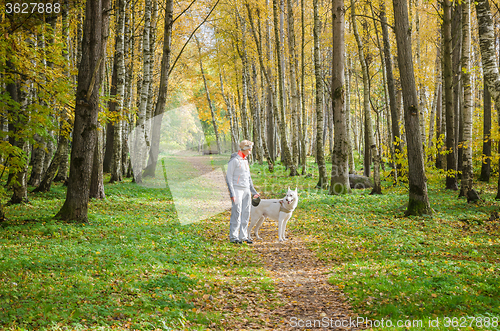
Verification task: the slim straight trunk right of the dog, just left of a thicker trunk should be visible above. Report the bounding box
[313,0,328,189]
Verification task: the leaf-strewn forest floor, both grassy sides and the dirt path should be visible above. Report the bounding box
[0,156,500,331]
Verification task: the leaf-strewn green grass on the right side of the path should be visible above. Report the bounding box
[254,161,500,330]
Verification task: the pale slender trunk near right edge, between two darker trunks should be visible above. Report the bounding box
[460,0,473,197]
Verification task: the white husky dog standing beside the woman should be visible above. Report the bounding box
[248,188,299,241]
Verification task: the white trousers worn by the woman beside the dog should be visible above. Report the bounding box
[229,187,252,241]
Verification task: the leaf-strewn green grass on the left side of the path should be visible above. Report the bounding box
[0,174,278,330]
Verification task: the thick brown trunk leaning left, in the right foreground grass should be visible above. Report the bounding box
[393,0,432,216]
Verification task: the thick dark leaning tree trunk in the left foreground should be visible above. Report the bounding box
[55,0,111,222]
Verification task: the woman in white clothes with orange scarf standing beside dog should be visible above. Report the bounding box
[226,140,259,244]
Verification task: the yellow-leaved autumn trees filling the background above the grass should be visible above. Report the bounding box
[1,0,498,220]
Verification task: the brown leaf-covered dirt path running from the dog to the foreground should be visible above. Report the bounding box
[248,221,359,330]
